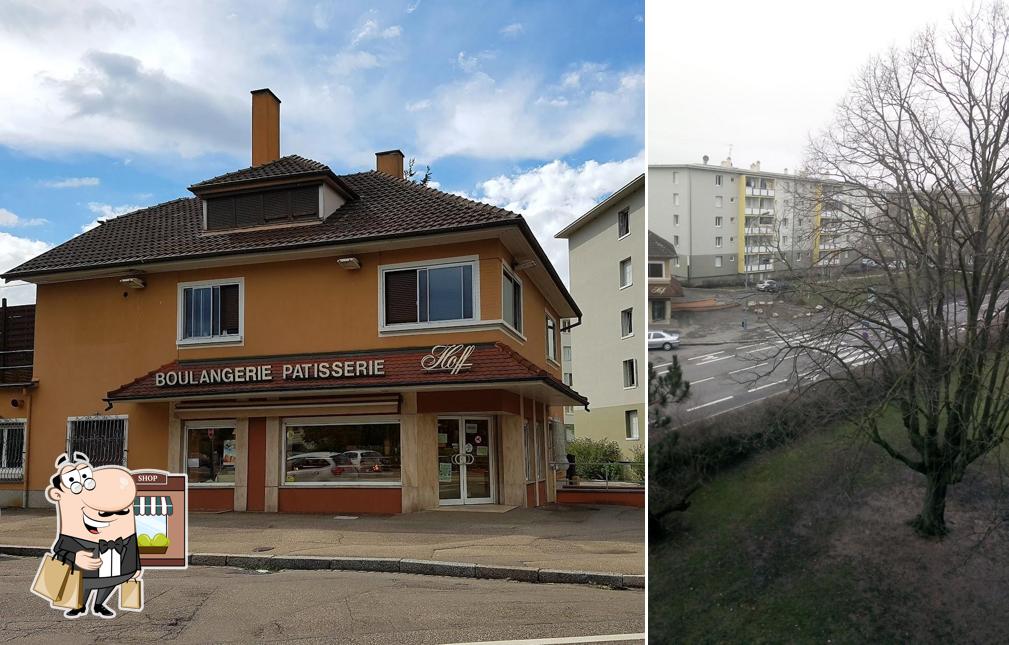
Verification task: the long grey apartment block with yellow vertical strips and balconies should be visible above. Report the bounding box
[648,157,858,286]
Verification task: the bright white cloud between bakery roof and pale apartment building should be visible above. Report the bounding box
[464,150,645,283]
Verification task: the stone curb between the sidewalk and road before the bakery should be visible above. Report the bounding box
[0,544,645,589]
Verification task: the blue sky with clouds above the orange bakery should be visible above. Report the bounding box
[0,0,645,302]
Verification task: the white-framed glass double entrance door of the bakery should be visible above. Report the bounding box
[438,418,495,505]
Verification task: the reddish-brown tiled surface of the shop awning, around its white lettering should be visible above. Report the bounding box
[107,343,588,405]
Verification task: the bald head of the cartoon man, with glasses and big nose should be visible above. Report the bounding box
[45,452,136,542]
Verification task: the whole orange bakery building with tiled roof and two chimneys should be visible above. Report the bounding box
[0,90,588,513]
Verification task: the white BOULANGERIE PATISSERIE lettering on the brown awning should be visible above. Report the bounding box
[154,358,385,388]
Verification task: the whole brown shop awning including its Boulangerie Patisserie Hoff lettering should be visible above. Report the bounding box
[106,343,588,406]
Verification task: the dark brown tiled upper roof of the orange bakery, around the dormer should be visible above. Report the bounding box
[3,166,524,280]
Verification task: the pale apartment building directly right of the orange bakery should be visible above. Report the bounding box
[556,175,648,456]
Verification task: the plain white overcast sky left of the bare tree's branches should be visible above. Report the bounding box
[646,0,970,172]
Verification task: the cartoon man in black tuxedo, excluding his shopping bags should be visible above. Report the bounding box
[45,452,141,618]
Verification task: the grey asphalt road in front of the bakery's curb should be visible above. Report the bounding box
[0,556,645,645]
